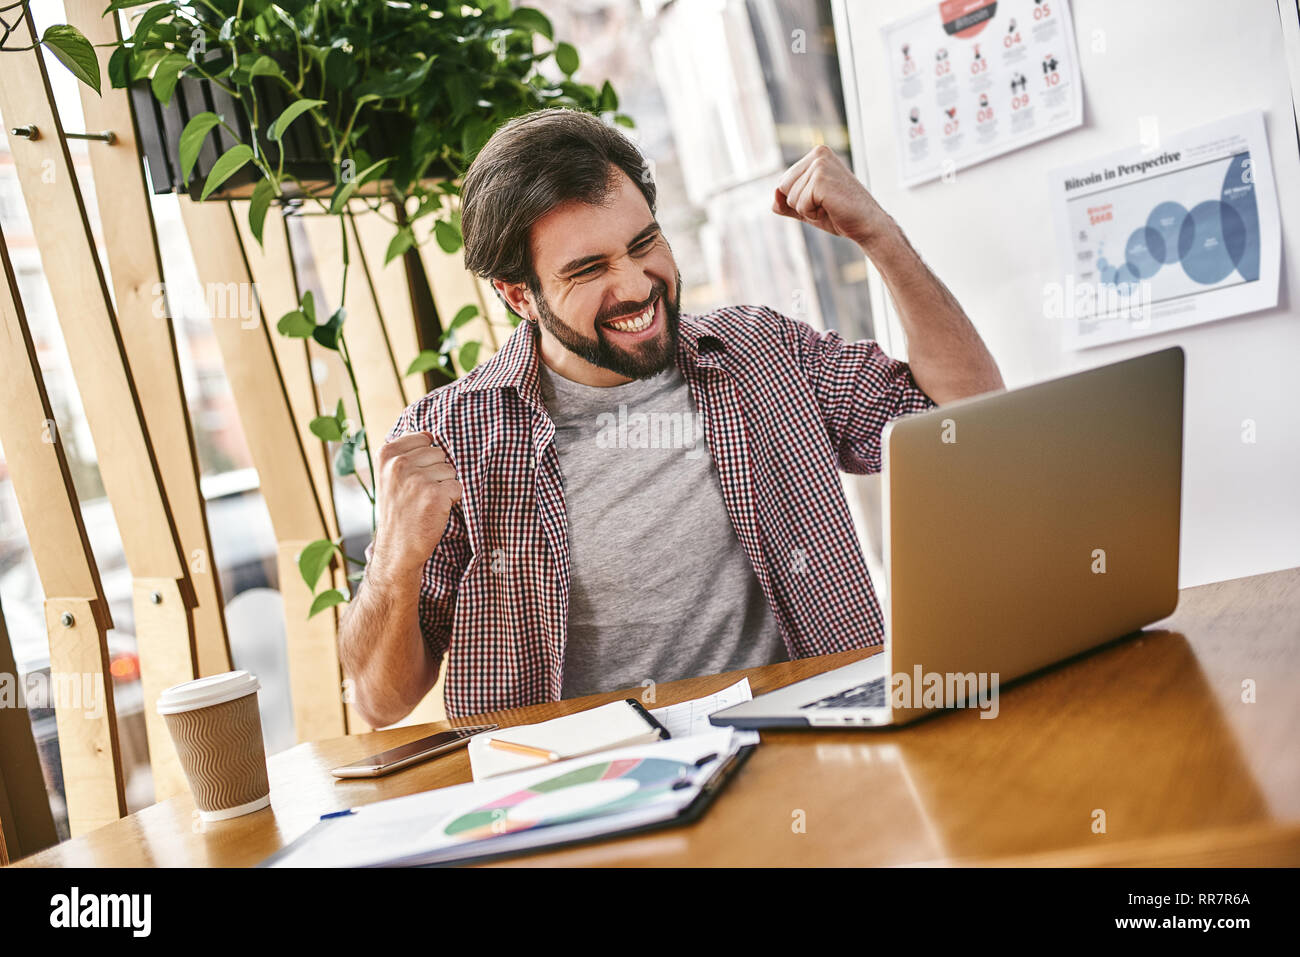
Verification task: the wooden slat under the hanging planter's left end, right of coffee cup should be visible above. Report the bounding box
[179,196,348,741]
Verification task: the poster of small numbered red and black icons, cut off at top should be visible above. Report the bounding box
[881,0,1083,186]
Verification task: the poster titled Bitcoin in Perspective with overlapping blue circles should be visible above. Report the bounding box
[1047,111,1290,348]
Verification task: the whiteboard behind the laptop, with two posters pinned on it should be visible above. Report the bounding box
[833,0,1300,588]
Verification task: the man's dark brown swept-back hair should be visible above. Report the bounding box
[460,107,655,291]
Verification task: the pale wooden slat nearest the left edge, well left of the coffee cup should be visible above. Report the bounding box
[0,226,126,837]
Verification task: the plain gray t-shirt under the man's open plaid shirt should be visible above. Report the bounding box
[538,361,789,698]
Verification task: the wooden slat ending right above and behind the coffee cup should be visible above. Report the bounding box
[64,0,231,681]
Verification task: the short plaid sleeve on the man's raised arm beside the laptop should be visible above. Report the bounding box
[777,313,939,475]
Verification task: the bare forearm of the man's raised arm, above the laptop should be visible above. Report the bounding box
[859,220,1006,404]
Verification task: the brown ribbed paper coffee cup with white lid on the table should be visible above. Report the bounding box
[157,671,270,820]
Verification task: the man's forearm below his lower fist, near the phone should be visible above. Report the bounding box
[338,562,438,727]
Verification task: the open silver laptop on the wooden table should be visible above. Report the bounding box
[710,346,1184,728]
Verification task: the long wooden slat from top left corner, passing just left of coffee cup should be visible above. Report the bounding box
[0,9,198,800]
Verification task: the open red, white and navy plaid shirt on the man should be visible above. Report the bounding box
[367,306,936,718]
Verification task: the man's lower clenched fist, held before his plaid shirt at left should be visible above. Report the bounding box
[373,432,463,575]
